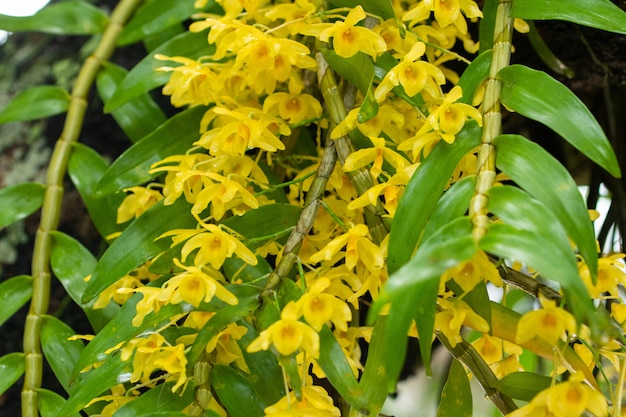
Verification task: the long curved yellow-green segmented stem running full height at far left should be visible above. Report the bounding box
[22,0,141,417]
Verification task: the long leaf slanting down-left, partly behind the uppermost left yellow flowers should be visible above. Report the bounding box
[104,31,215,113]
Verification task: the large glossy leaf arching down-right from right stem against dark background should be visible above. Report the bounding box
[498,65,621,177]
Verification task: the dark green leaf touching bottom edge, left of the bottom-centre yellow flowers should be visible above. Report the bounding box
[210,365,264,417]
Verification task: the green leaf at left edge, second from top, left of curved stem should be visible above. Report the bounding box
[0,84,70,124]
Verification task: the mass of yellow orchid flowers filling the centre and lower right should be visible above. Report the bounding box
[78,0,626,417]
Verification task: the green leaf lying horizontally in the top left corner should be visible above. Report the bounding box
[0,0,109,35]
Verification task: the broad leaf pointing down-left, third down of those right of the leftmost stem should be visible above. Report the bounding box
[82,199,196,302]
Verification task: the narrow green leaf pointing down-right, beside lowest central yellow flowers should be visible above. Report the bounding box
[317,326,360,408]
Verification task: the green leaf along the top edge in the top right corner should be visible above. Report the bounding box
[511,0,626,34]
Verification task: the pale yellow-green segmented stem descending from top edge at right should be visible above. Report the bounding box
[470,0,513,241]
